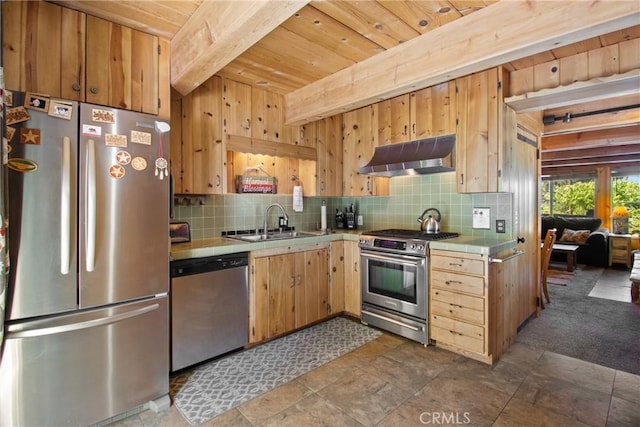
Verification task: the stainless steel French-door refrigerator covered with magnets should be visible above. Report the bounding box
[0,92,169,426]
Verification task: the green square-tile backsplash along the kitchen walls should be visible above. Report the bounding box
[173,172,513,239]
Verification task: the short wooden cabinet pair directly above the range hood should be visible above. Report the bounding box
[378,82,456,145]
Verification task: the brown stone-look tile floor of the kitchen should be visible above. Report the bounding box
[105,326,640,427]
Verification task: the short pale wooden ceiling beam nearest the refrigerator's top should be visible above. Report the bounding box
[171,0,309,95]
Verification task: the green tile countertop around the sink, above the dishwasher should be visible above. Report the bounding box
[170,230,366,260]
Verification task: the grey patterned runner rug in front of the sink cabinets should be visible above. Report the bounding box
[174,317,382,424]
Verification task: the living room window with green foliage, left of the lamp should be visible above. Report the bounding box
[540,178,596,216]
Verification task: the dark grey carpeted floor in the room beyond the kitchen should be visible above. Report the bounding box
[517,266,640,375]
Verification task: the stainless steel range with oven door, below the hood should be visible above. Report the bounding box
[358,229,458,345]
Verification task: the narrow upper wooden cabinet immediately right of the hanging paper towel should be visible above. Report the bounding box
[316,115,343,196]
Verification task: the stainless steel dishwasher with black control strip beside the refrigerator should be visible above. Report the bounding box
[170,252,249,371]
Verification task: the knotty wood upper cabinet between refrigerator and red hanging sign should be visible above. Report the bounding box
[171,76,227,194]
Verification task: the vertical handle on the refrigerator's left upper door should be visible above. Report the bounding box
[60,136,71,275]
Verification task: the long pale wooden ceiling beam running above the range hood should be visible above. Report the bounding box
[285,0,640,124]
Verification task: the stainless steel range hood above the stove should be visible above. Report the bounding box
[359,134,456,177]
